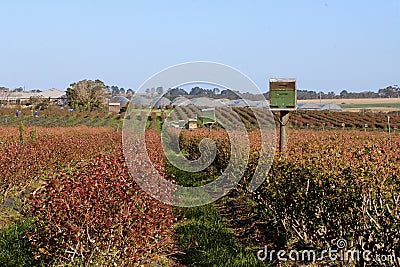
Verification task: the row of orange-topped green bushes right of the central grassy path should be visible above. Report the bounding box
[180,130,400,266]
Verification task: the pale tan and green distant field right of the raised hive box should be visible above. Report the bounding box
[298,98,400,112]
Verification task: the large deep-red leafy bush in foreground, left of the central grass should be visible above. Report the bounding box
[29,149,175,266]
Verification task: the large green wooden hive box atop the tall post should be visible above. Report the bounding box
[269,78,297,110]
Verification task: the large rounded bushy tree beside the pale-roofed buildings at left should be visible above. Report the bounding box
[67,80,109,110]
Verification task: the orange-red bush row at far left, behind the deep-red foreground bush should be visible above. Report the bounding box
[0,126,121,203]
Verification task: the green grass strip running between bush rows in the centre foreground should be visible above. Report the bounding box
[167,165,266,266]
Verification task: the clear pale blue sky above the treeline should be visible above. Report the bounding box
[0,0,400,93]
